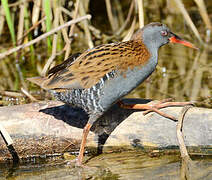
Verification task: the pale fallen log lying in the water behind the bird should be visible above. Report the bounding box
[0,99,212,160]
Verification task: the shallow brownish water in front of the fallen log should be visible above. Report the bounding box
[0,151,212,180]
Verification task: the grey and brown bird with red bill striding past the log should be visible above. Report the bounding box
[28,22,197,165]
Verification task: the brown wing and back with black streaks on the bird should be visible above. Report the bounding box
[41,40,150,89]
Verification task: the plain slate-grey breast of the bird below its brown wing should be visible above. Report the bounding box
[99,57,157,110]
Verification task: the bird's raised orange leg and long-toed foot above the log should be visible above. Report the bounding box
[119,99,194,121]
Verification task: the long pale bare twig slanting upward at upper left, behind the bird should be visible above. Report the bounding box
[0,15,91,59]
